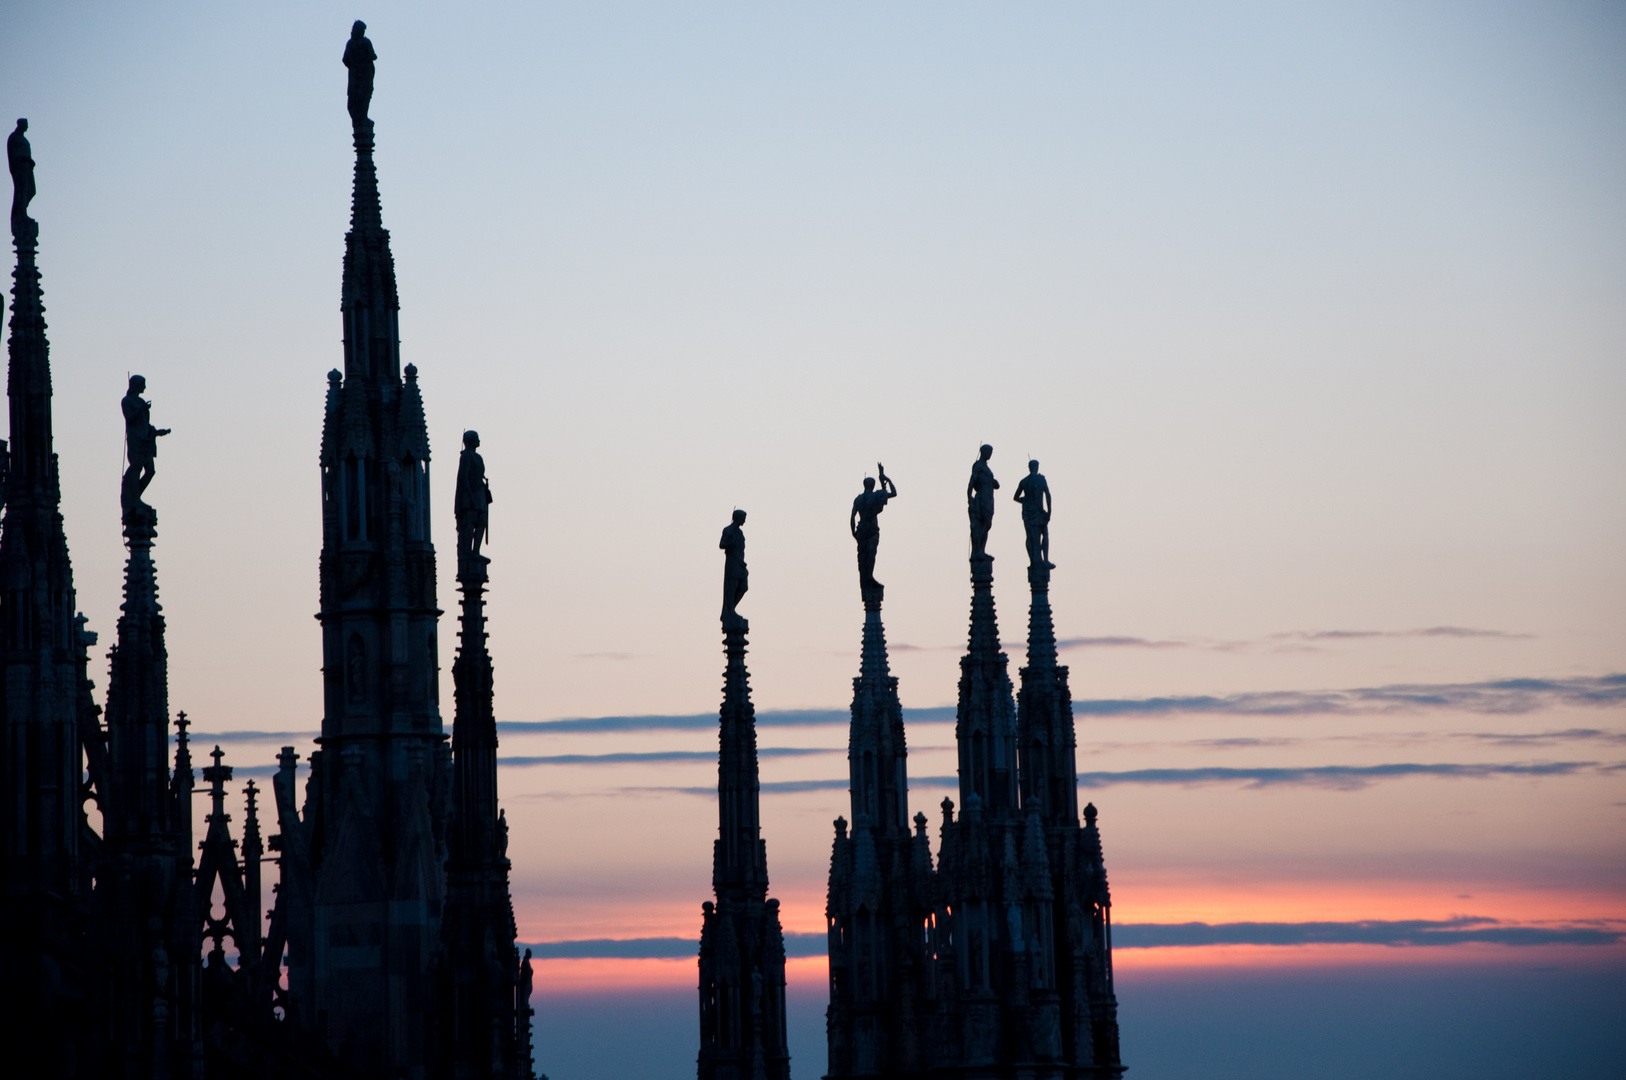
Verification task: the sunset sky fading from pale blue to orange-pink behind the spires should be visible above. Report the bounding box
[0,0,1626,1080]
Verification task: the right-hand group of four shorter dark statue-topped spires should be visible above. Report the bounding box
[699,446,1125,1080]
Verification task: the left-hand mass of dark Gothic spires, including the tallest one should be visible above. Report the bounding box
[0,23,535,1080]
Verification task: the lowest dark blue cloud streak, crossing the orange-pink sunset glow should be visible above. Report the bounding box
[522,916,1626,960]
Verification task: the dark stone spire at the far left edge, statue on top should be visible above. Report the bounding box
[0,120,106,1046]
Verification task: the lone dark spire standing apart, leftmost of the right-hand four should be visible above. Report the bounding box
[699,511,790,1080]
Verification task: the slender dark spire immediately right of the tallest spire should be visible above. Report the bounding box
[441,449,533,1080]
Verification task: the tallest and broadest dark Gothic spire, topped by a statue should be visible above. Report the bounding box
[273,24,450,1075]
